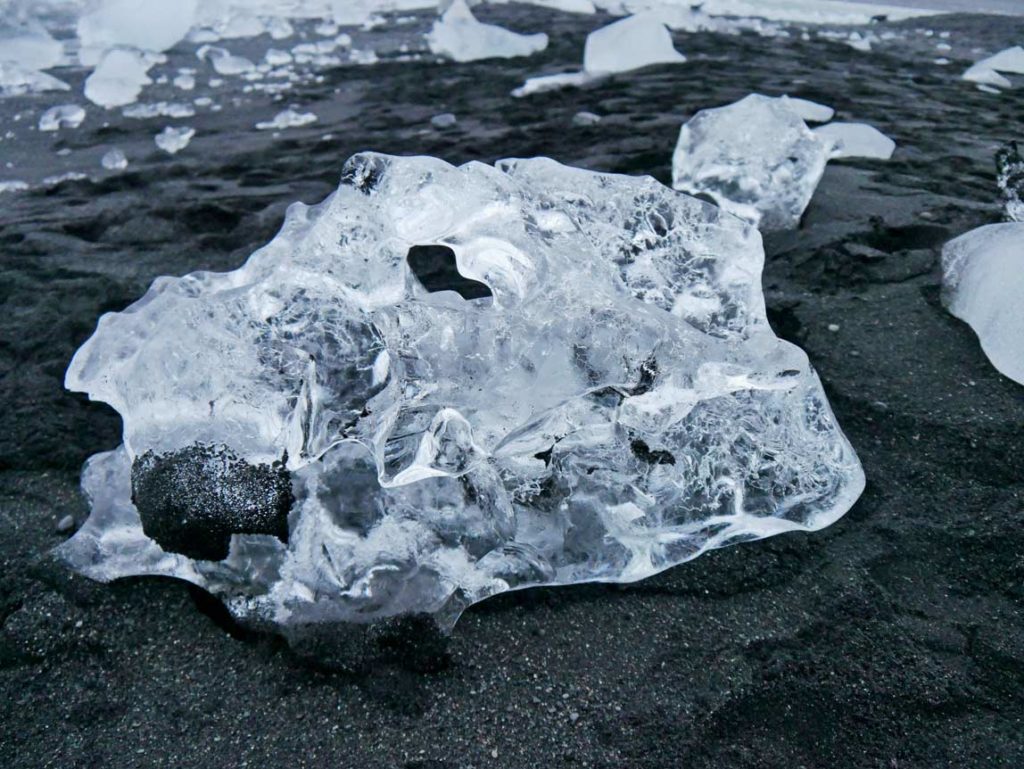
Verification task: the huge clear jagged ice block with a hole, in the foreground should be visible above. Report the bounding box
[59,151,864,628]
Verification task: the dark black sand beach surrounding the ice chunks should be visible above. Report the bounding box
[0,8,1024,769]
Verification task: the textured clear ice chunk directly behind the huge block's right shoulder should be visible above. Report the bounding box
[672,93,833,230]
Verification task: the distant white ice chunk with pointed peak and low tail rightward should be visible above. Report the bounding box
[427,0,548,61]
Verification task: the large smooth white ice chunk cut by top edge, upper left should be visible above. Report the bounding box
[78,0,199,65]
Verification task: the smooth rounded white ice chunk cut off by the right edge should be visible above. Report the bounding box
[942,221,1024,384]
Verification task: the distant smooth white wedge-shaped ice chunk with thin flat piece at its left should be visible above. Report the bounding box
[583,13,686,75]
